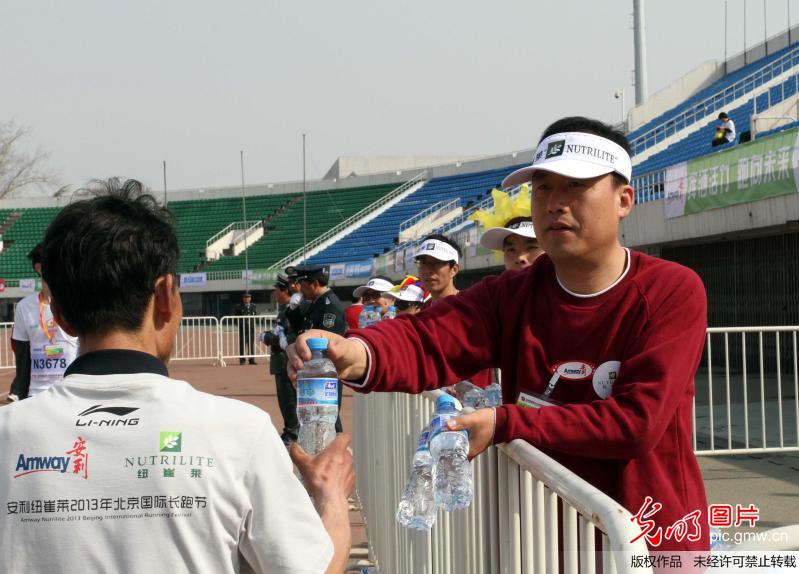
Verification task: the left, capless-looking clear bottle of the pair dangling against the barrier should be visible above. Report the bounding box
[396,427,436,530]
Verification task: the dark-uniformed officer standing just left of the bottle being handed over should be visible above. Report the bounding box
[259,273,300,446]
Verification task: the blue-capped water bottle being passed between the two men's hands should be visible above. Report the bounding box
[297,338,339,454]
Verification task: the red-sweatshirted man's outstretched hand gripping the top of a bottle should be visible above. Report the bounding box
[286,329,368,381]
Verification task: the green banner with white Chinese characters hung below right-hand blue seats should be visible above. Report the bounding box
[665,128,799,218]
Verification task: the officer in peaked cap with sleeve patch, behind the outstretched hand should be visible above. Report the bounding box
[296,265,347,432]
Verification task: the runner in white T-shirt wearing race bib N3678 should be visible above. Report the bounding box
[11,244,78,399]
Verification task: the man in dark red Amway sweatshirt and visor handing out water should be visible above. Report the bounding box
[290,117,709,551]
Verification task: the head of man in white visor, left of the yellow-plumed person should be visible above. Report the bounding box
[413,233,463,304]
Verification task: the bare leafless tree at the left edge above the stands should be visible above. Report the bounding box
[0,121,58,199]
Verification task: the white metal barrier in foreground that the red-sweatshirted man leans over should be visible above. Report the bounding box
[353,393,651,574]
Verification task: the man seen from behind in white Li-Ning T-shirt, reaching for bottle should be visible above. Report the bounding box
[0,180,355,573]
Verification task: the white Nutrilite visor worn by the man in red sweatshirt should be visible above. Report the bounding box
[502,132,633,187]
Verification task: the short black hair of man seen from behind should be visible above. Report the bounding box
[42,178,180,335]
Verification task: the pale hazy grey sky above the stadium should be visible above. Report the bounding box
[0,0,799,195]
